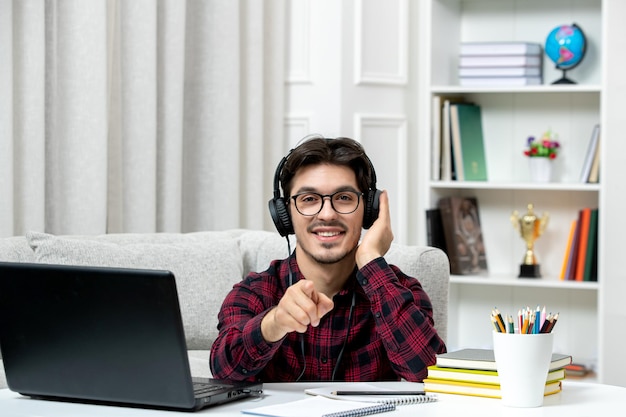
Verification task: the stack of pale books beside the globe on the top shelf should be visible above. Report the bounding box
[459,42,543,86]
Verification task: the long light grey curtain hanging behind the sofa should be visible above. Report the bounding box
[0,0,285,236]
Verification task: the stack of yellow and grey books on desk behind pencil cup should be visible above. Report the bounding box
[424,349,572,398]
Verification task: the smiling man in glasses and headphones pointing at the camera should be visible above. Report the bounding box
[210,138,446,382]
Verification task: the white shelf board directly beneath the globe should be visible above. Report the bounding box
[430,84,602,94]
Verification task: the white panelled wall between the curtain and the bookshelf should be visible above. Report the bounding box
[285,0,418,243]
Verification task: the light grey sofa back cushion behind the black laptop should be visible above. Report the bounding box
[26,232,243,350]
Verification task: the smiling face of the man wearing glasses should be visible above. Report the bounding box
[289,164,364,264]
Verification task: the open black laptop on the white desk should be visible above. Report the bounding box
[0,262,262,410]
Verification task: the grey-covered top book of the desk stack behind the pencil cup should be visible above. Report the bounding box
[435,348,572,371]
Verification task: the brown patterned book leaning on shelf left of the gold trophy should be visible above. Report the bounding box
[437,196,487,275]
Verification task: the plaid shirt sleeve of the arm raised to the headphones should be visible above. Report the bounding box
[357,257,446,381]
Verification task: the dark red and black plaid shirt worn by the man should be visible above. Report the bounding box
[210,257,446,382]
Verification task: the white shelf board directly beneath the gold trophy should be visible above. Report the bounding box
[450,275,598,291]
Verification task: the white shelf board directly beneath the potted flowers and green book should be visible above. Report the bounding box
[430,181,600,192]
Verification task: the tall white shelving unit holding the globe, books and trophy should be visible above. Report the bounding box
[418,0,626,384]
